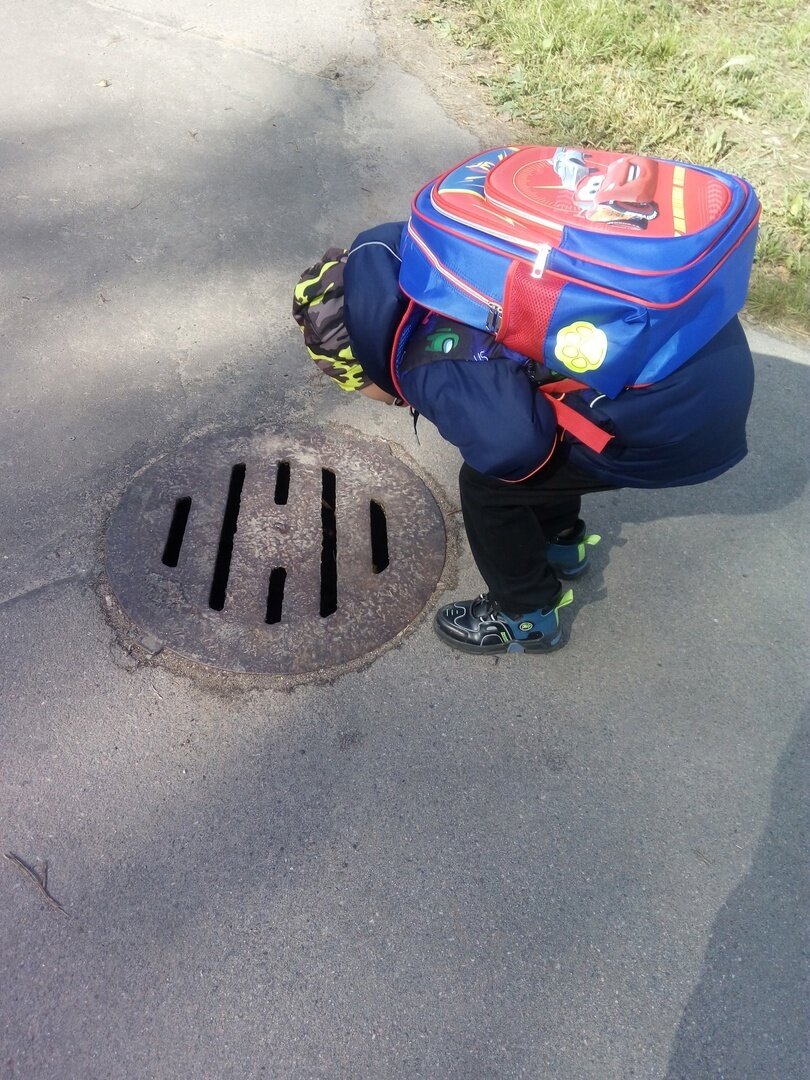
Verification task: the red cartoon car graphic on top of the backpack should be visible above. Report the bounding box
[551,147,659,229]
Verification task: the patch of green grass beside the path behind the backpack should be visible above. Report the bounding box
[415,0,810,333]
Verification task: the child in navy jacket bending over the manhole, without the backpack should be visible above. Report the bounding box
[293,222,754,653]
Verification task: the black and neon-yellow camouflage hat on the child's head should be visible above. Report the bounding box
[293,247,369,390]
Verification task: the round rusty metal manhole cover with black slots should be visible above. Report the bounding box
[107,429,445,675]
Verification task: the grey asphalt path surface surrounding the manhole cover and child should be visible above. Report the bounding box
[0,0,810,1080]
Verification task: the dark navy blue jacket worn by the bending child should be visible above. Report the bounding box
[343,222,754,487]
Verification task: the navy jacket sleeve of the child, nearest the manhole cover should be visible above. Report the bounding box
[401,360,556,482]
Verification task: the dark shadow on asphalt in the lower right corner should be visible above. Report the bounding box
[666,718,810,1080]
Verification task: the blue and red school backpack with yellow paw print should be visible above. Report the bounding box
[392,146,761,448]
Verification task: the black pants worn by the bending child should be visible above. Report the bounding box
[459,458,617,615]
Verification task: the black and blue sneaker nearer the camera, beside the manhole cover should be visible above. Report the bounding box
[433,589,573,652]
